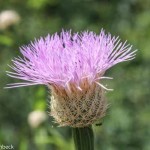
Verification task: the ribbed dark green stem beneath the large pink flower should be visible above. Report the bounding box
[72,126,94,150]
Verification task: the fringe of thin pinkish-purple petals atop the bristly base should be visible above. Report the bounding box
[7,30,136,90]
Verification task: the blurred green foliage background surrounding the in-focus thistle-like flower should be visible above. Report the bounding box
[0,0,150,150]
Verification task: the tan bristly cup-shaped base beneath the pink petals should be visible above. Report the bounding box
[50,84,107,128]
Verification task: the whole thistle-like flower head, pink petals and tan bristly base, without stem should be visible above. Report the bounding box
[7,30,136,127]
